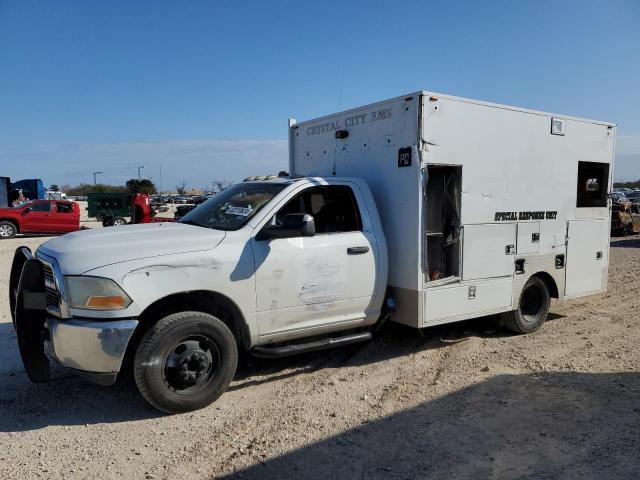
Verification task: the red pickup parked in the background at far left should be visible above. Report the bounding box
[0,200,80,239]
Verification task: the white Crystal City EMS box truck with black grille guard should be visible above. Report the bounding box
[10,91,615,412]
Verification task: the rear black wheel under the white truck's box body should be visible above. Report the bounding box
[502,277,551,333]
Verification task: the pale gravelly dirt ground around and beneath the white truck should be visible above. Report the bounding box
[0,228,640,479]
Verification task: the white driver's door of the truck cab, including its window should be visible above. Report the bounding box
[252,185,378,337]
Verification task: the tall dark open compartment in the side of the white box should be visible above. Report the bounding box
[426,165,462,282]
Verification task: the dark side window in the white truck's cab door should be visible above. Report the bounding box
[275,185,362,233]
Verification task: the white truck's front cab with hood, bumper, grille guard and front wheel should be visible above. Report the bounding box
[11,177,387,412]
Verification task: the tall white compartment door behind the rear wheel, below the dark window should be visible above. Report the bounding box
[565,220,607,297]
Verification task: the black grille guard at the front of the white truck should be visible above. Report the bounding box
[9,247,49,383]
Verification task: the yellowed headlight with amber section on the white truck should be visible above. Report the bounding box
[65,276,131,310]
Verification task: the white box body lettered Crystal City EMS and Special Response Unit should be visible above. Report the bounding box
[289,91,615,327]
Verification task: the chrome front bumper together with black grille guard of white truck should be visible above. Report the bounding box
[9,247,138,385]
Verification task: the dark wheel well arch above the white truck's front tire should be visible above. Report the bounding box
[132,290,251,347]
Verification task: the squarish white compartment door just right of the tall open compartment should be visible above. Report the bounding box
[462,223,516,280]
